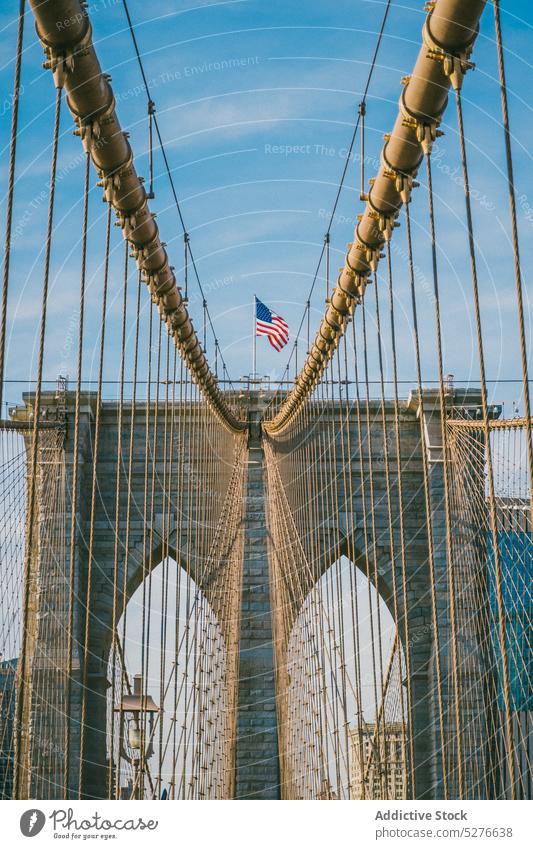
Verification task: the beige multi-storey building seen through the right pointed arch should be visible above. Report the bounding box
[350,722,407,799]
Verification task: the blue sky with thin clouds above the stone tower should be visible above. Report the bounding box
[0,0,533,412]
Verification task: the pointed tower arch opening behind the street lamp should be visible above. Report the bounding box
[107,556,234,799]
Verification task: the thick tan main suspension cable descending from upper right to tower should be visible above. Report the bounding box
[264,0,486,434]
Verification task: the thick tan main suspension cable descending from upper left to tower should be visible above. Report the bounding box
[31,0,245,433]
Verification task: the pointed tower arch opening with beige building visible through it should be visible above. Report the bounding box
[278,556,408,799]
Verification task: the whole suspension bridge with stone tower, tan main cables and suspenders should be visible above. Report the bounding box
[0,0,533,800]
